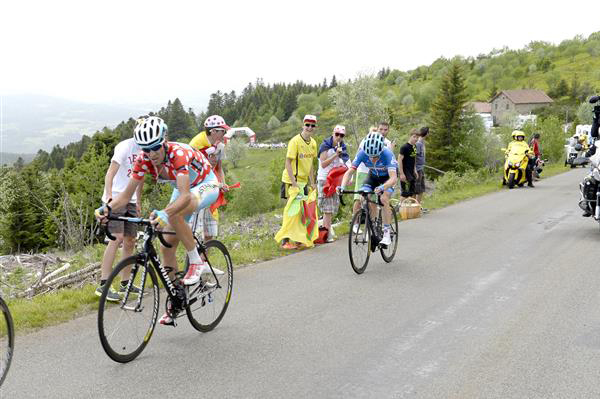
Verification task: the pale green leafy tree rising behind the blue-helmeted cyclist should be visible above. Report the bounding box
[330,75,385,147]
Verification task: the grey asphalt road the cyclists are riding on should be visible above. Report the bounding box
[0,169,600,399]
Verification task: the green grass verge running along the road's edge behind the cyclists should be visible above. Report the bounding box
[8,164,570,333]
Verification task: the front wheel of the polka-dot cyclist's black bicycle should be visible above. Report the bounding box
[98,255,159,363]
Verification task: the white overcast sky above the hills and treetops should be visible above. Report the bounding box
[0,0,600,109]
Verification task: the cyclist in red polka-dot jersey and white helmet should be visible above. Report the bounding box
[96,116,223,325]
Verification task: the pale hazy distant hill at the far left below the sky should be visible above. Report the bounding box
[0,95,158,153]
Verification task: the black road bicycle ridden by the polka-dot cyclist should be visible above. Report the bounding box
[98,215,233,363]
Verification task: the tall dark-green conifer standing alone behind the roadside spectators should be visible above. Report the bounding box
[428,63,467,171]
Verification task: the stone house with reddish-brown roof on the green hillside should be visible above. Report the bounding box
[491,89,554,126]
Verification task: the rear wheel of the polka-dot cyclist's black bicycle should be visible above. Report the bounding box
[185,240,233,332]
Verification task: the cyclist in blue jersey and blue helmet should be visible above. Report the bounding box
[338,132,398,245]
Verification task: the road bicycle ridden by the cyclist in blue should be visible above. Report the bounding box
[342,190,398,274]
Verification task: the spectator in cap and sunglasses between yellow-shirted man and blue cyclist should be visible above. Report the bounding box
[317,125,350,242]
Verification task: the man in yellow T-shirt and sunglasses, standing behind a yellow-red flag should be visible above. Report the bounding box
[280,115,317,249]
